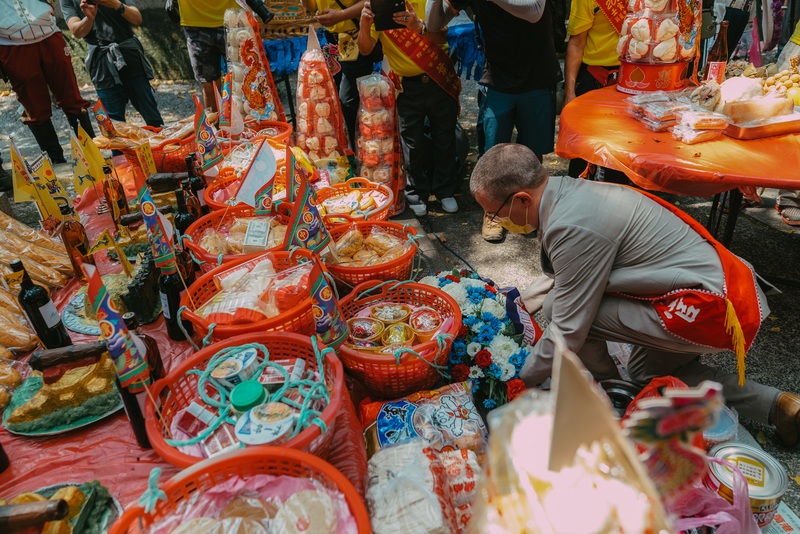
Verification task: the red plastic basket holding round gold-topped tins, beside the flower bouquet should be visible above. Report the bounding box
[339,280,461,398]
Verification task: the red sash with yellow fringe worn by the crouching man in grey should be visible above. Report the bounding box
[616,190,764,385]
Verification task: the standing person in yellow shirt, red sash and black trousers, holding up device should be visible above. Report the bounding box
[358,0,461,217]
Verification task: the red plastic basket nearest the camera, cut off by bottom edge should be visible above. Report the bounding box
[108,447,372,534]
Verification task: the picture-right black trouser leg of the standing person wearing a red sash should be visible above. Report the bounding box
[423,80,458,205]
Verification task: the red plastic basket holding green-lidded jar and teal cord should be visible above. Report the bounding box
[145,332,344,468]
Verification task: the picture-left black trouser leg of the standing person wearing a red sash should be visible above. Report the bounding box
[397,82,431,214]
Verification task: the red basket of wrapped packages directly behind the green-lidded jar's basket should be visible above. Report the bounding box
[181,249,318,339]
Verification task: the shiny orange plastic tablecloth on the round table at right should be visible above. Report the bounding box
[556,87,800,197]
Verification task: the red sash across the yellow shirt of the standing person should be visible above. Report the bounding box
[383,28,461,102]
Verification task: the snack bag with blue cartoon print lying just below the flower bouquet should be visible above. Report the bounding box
[361,381,487,457]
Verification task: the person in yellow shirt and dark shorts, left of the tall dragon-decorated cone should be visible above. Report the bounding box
[178,0,239,111]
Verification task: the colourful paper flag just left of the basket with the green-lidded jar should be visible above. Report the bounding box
[79,260,150,393]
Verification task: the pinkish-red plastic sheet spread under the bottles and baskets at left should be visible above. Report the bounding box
[0,157,367,508]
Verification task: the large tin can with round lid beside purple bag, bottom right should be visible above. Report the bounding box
[703,442,789,530]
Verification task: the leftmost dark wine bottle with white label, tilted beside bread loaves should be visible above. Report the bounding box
[9,260,72,349]
